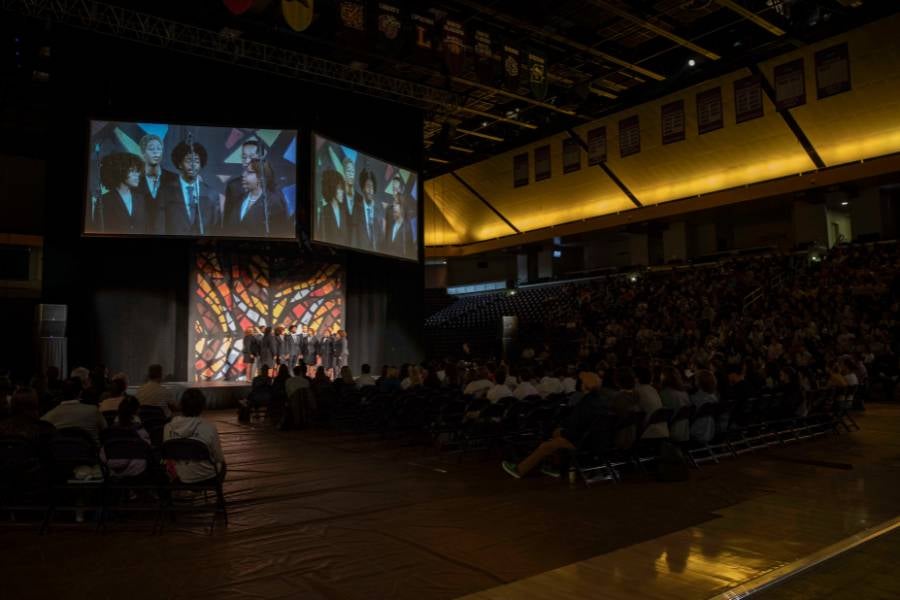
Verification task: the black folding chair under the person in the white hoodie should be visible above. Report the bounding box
[160,438,228,533]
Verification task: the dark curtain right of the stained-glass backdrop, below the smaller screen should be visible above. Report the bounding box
[346,253,424,374]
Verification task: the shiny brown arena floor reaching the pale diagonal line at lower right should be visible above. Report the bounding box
[0,406,900,600]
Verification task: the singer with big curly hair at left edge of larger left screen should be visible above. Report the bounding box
[93,152,147,234]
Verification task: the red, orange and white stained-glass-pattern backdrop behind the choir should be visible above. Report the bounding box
[188,249,344,381]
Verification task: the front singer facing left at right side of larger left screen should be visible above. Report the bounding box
[224,158,293,237]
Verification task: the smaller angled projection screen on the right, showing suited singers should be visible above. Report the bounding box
[312,134,419,261]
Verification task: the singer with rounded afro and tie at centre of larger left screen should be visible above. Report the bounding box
[160,142,221,236]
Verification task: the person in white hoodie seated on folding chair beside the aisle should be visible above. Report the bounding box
[163,389,226,483]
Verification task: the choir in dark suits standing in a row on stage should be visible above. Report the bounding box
[243,324,350,381]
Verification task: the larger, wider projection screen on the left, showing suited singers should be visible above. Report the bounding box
[84,121,297,239]
